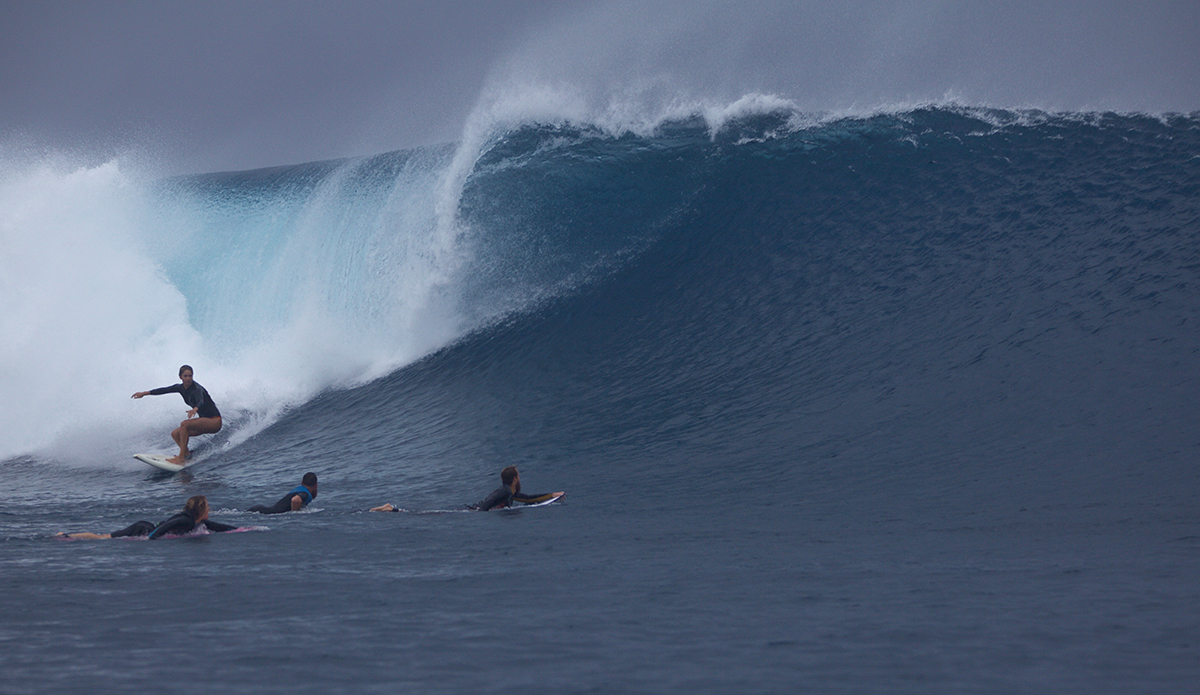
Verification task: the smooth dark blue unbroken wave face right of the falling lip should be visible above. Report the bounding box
[225,109,1200,513]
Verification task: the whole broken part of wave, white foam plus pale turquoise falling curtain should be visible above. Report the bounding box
[0,144,469,466]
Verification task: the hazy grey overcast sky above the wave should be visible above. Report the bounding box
[0,0,1200,172]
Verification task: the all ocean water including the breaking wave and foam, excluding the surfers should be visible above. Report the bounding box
[0,103,1200,695]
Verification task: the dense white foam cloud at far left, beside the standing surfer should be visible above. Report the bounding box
[0,161,204,459]
